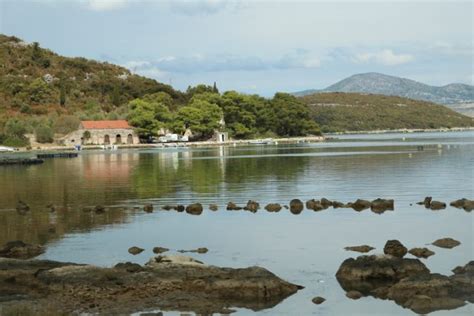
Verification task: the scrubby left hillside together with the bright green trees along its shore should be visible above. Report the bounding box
[0,35,320,146]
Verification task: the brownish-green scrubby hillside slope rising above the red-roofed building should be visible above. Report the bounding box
[0,34,184,119]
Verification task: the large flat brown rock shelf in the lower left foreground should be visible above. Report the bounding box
[0,255,302,315]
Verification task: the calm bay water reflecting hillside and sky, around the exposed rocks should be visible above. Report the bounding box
[0,132,474,315]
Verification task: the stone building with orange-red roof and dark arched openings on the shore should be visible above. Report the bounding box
[60,120,140,145]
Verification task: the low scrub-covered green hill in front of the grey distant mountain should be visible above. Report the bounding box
[300,92,474,132]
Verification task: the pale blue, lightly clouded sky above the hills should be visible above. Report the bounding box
[0,0,474,96]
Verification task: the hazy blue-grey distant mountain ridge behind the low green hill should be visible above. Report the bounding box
[294,72,474,105]
